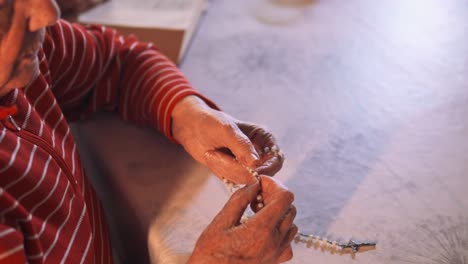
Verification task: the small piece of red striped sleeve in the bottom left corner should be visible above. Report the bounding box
[0,224,27,264]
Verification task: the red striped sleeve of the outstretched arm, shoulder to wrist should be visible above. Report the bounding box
[43,20,219,140]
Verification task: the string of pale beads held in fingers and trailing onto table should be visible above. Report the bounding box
[223,146,377,256]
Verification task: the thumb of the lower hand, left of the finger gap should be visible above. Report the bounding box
[213,182,260,229]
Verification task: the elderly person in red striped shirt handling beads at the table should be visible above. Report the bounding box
[0,0,297,263]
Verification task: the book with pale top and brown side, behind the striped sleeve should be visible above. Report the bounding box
[78,0,208,64]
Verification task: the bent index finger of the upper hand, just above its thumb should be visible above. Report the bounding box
[223,124,260,168]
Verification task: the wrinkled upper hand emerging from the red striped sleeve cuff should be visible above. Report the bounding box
[172,96,283,184]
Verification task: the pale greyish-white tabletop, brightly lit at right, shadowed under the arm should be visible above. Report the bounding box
[74,0,468,264]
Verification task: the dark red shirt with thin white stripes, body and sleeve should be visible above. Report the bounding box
[0,21,215,263]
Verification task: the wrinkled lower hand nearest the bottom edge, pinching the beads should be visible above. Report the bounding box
[188,176,297,264]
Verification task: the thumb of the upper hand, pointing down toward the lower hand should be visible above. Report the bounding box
[205,150,256,184]
